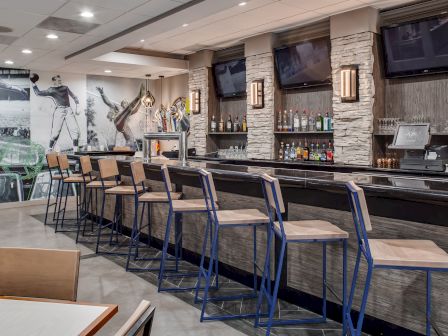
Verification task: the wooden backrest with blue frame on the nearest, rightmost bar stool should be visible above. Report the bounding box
[345,181,372,255]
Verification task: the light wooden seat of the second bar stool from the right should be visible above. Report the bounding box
[274,220,348,240]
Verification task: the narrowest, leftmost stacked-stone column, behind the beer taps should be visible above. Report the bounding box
[188,67,209,155]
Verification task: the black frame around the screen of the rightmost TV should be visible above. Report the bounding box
[380,14,448,79]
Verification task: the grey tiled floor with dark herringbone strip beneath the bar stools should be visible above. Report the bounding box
[0,201,342,336]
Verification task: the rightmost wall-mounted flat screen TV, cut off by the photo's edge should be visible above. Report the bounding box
[382,15,448,78]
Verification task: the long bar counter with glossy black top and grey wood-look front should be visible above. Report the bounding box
[71,155,448,335]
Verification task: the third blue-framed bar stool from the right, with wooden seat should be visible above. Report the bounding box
[195,169,269,322]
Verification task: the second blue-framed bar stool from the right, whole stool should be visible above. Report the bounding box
[255,174,349,336]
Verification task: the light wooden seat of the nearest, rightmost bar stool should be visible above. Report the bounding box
[369,239,448,268]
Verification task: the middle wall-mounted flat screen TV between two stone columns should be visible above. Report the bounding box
[275,37,331,89]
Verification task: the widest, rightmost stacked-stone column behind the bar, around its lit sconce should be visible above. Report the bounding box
[331,32,376,165]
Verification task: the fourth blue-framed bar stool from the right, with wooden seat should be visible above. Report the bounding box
[158,165,218,292]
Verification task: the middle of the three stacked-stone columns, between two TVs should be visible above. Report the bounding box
[246,53,275,159]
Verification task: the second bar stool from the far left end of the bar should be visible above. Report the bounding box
[55,154,93,232]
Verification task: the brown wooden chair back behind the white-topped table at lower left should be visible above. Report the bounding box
[0,247,80,301]
